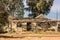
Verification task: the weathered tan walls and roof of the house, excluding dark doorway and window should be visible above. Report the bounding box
[8,15,60,31]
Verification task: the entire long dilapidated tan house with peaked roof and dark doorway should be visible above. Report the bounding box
[3,14,60,32]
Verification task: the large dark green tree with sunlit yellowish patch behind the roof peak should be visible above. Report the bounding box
[27,0,54,18]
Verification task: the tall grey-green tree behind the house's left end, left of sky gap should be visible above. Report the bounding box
[4,0,24,18]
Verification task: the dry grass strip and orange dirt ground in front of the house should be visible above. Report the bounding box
[0,31,60,40]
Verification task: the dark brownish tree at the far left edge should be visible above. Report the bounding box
[0,0,8,26]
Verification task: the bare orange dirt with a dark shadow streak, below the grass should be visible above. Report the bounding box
[0,34,60,40]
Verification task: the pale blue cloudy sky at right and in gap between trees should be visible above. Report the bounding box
[24,0,60,20]
